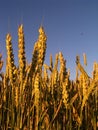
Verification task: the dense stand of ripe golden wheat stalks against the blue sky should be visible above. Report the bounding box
[0,25,98,130]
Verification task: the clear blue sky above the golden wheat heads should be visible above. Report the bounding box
[0,0,98,79]
